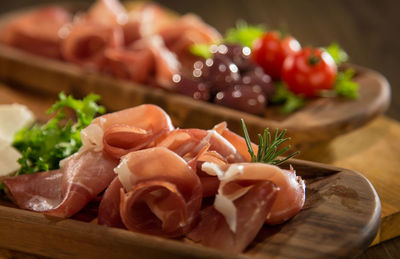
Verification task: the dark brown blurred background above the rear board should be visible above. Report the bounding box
[0,0,400,120]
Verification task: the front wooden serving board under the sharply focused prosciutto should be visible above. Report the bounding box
[0,160,381,258]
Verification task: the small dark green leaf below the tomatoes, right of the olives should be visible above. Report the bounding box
[271,81,305,114]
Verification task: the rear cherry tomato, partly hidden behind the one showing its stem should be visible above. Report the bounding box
[252,31,301,80]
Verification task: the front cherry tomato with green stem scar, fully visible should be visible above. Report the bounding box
[282,48,337,97]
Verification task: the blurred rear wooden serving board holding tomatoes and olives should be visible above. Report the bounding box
[0,5,390,149]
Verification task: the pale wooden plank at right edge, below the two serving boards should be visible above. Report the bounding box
[301,117,400,243]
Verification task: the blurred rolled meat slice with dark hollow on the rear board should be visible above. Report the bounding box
[61,21,123,69]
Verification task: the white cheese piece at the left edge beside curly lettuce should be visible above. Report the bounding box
[0,103,35,143]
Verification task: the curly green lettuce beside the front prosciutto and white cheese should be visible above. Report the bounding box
[13,93,105,175]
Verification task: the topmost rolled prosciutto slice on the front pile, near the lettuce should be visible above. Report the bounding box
[81,104,174,158]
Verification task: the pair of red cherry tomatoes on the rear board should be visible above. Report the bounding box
[252,31,337,97]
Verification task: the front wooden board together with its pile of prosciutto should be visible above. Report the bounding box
[0,105,380,258]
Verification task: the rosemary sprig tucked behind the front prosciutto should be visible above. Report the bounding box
[240,119,300,165]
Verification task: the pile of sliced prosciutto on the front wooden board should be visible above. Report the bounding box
[3,105,305,252]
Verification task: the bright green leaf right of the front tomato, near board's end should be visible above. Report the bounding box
[335,69,359,99]
